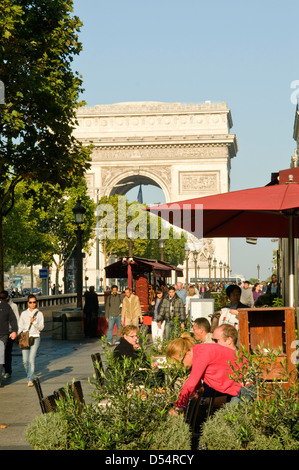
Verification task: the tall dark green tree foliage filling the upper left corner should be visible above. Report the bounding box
[0,0,90,283]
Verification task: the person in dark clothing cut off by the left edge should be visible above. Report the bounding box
[0,299,18,387]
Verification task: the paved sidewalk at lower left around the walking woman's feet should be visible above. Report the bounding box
[0,337,102,450]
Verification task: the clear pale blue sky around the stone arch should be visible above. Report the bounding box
[74,0,299,279]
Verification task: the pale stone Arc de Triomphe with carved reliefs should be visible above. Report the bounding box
[74,101,238,285]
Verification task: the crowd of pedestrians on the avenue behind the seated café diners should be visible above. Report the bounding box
[105,274,281,345]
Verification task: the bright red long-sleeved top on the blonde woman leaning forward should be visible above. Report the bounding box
[175,343,242,408]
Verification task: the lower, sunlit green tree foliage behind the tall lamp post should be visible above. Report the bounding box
[3,178,95,284]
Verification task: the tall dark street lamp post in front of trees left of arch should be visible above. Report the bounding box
[73,198,86,308]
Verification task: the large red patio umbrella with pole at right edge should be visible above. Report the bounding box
[147,168,299,306]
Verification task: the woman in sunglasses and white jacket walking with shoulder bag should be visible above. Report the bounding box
[18,294,44,387]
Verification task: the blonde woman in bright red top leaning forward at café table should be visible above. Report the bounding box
[166,333,246,411]
